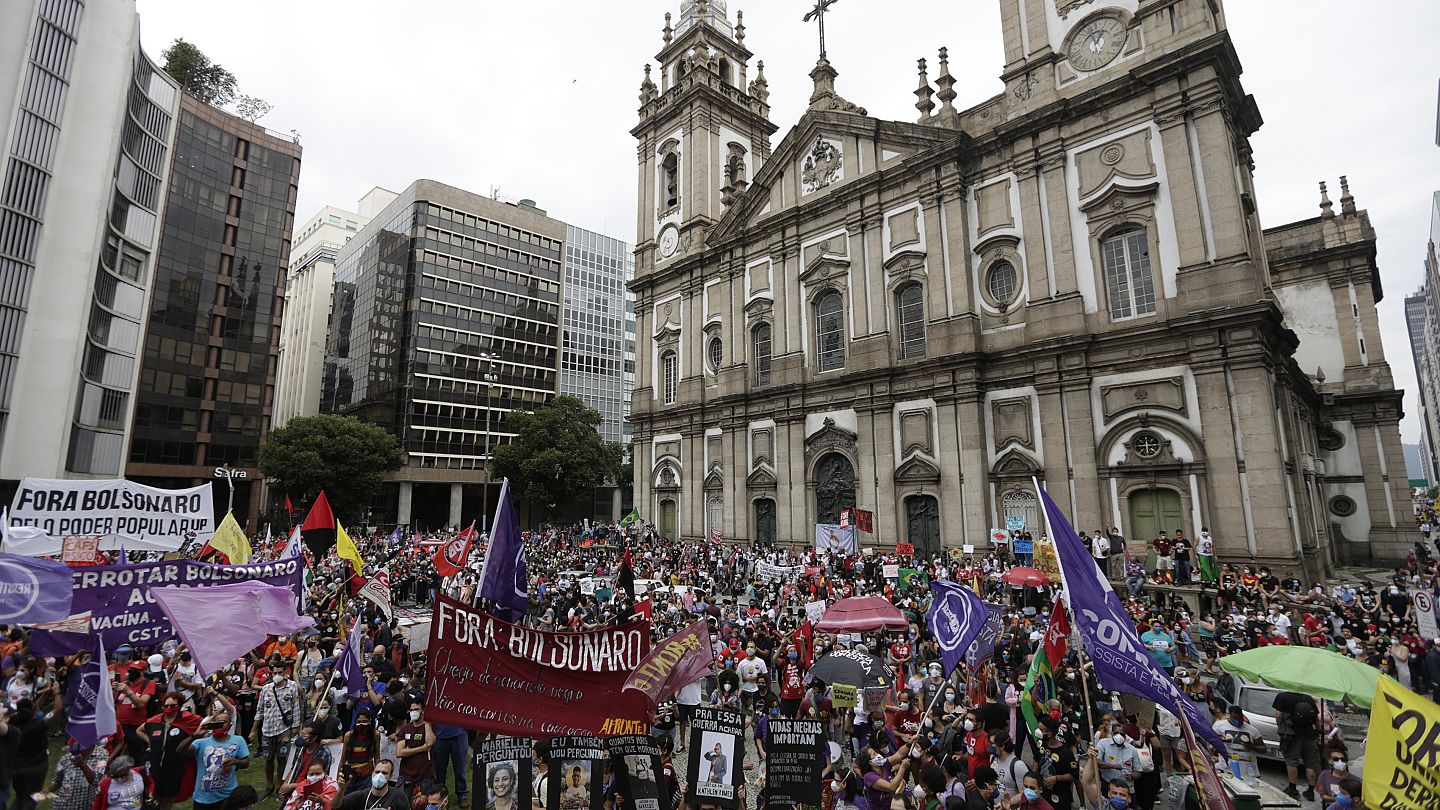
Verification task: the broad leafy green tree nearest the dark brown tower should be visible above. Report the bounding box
[261,415,405,523]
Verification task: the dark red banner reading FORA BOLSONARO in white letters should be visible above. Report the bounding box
[425,597,649,736]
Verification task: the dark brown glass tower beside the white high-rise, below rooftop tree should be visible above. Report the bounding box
[125,95,301,526]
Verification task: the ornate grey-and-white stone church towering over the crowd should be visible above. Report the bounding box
[631,0,1414,577]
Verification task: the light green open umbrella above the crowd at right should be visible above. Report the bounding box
[1220,644,1380,709]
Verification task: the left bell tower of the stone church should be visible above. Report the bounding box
[631,0,775,275]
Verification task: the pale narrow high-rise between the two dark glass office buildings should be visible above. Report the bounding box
[271,187,396,428]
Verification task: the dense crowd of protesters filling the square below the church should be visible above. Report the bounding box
[0,469,1440,810]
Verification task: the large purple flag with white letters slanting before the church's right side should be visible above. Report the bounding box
[1035,483,1225,751]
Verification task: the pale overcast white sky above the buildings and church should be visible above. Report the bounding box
[140,0,1440,442]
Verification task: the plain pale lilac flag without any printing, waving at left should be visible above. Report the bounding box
[150,579,315,676]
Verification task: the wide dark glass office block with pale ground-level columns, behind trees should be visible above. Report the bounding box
[321,180,566,528]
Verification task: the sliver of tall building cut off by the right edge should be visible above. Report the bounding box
[1405,192,1440,484]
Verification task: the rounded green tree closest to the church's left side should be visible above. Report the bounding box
[492,396,622,517]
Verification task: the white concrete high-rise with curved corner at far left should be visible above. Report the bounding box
[0,0,180,500]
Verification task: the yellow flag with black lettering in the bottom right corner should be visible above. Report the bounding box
[1364,675,1440,810]
